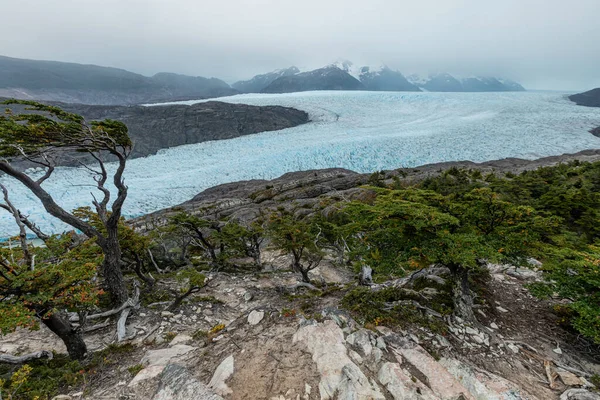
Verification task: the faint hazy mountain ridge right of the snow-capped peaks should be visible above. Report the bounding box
[408,72,525,92]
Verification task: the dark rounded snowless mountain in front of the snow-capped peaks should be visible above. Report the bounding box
[262,66,365,93]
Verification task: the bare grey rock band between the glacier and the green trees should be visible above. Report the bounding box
[135,149,600,230]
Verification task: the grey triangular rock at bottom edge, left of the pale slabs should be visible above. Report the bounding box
[152,364,223,400]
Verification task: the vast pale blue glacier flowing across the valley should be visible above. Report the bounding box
[0,92,600,237]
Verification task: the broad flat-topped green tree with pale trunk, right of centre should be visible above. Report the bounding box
[343,188,556,322]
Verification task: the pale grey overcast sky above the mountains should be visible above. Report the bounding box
[0,0,600,90]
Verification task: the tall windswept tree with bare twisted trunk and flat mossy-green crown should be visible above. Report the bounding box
[0,100,132,303]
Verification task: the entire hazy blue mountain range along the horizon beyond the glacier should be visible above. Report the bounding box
[0,56,525,105]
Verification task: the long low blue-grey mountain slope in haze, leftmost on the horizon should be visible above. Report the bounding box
[0,56,238,104]
